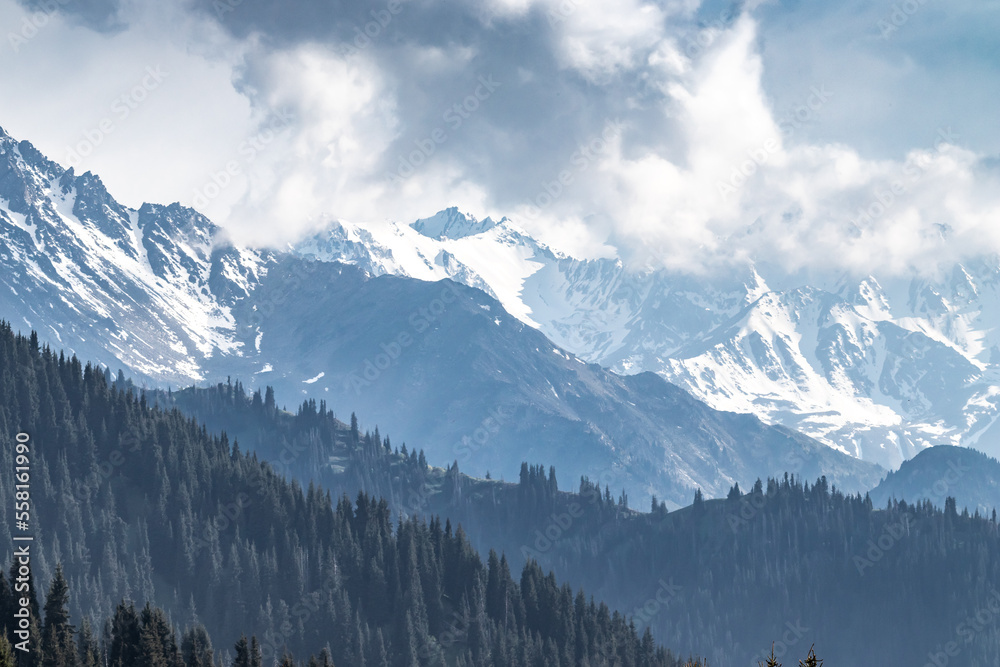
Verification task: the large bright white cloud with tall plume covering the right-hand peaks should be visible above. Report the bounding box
[504,16,1000,280]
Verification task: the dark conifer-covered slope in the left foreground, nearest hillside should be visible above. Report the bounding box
[0,324,700,667]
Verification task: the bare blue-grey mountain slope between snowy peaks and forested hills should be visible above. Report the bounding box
[229,256,884,507]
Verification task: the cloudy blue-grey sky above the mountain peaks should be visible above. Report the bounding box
[0,0,1000,274]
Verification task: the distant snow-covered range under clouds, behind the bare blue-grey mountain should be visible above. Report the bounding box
[296,209,1000,467]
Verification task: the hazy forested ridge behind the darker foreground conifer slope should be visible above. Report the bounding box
[146,380,1000,667]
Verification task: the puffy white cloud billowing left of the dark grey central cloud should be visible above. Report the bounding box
[214,44,397,242]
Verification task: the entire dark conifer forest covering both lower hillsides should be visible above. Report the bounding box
[9,326,1000,667]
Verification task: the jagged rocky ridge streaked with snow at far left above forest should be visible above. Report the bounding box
[0,127,267,382]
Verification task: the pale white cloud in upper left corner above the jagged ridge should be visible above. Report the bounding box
[0,0,254,206]
